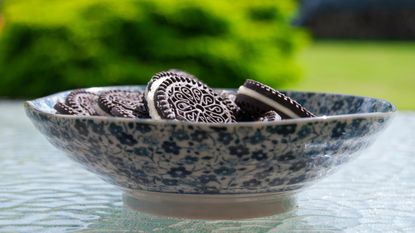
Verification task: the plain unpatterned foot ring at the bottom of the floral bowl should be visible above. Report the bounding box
[123,192,296,220]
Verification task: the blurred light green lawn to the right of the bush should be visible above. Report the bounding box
[286,41,415,110]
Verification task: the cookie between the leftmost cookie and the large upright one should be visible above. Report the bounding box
[96,90,149,118]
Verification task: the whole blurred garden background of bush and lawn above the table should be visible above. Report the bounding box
[0,0,415,110]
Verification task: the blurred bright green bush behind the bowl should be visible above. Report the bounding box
[0,0,306,97]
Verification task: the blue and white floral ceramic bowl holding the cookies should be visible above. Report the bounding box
[25,86,395,219]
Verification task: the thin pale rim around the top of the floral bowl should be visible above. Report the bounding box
[24,85,396,127]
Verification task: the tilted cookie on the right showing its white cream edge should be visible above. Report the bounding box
[235,79,315,119]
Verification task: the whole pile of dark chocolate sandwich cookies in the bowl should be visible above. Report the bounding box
[54,70,315,123]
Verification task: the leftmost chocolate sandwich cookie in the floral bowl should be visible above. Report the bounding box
[54,90,98,116]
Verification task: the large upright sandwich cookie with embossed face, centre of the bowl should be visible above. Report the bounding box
[146,71,235,123]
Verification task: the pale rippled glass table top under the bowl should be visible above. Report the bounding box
[0,101,415,232]
